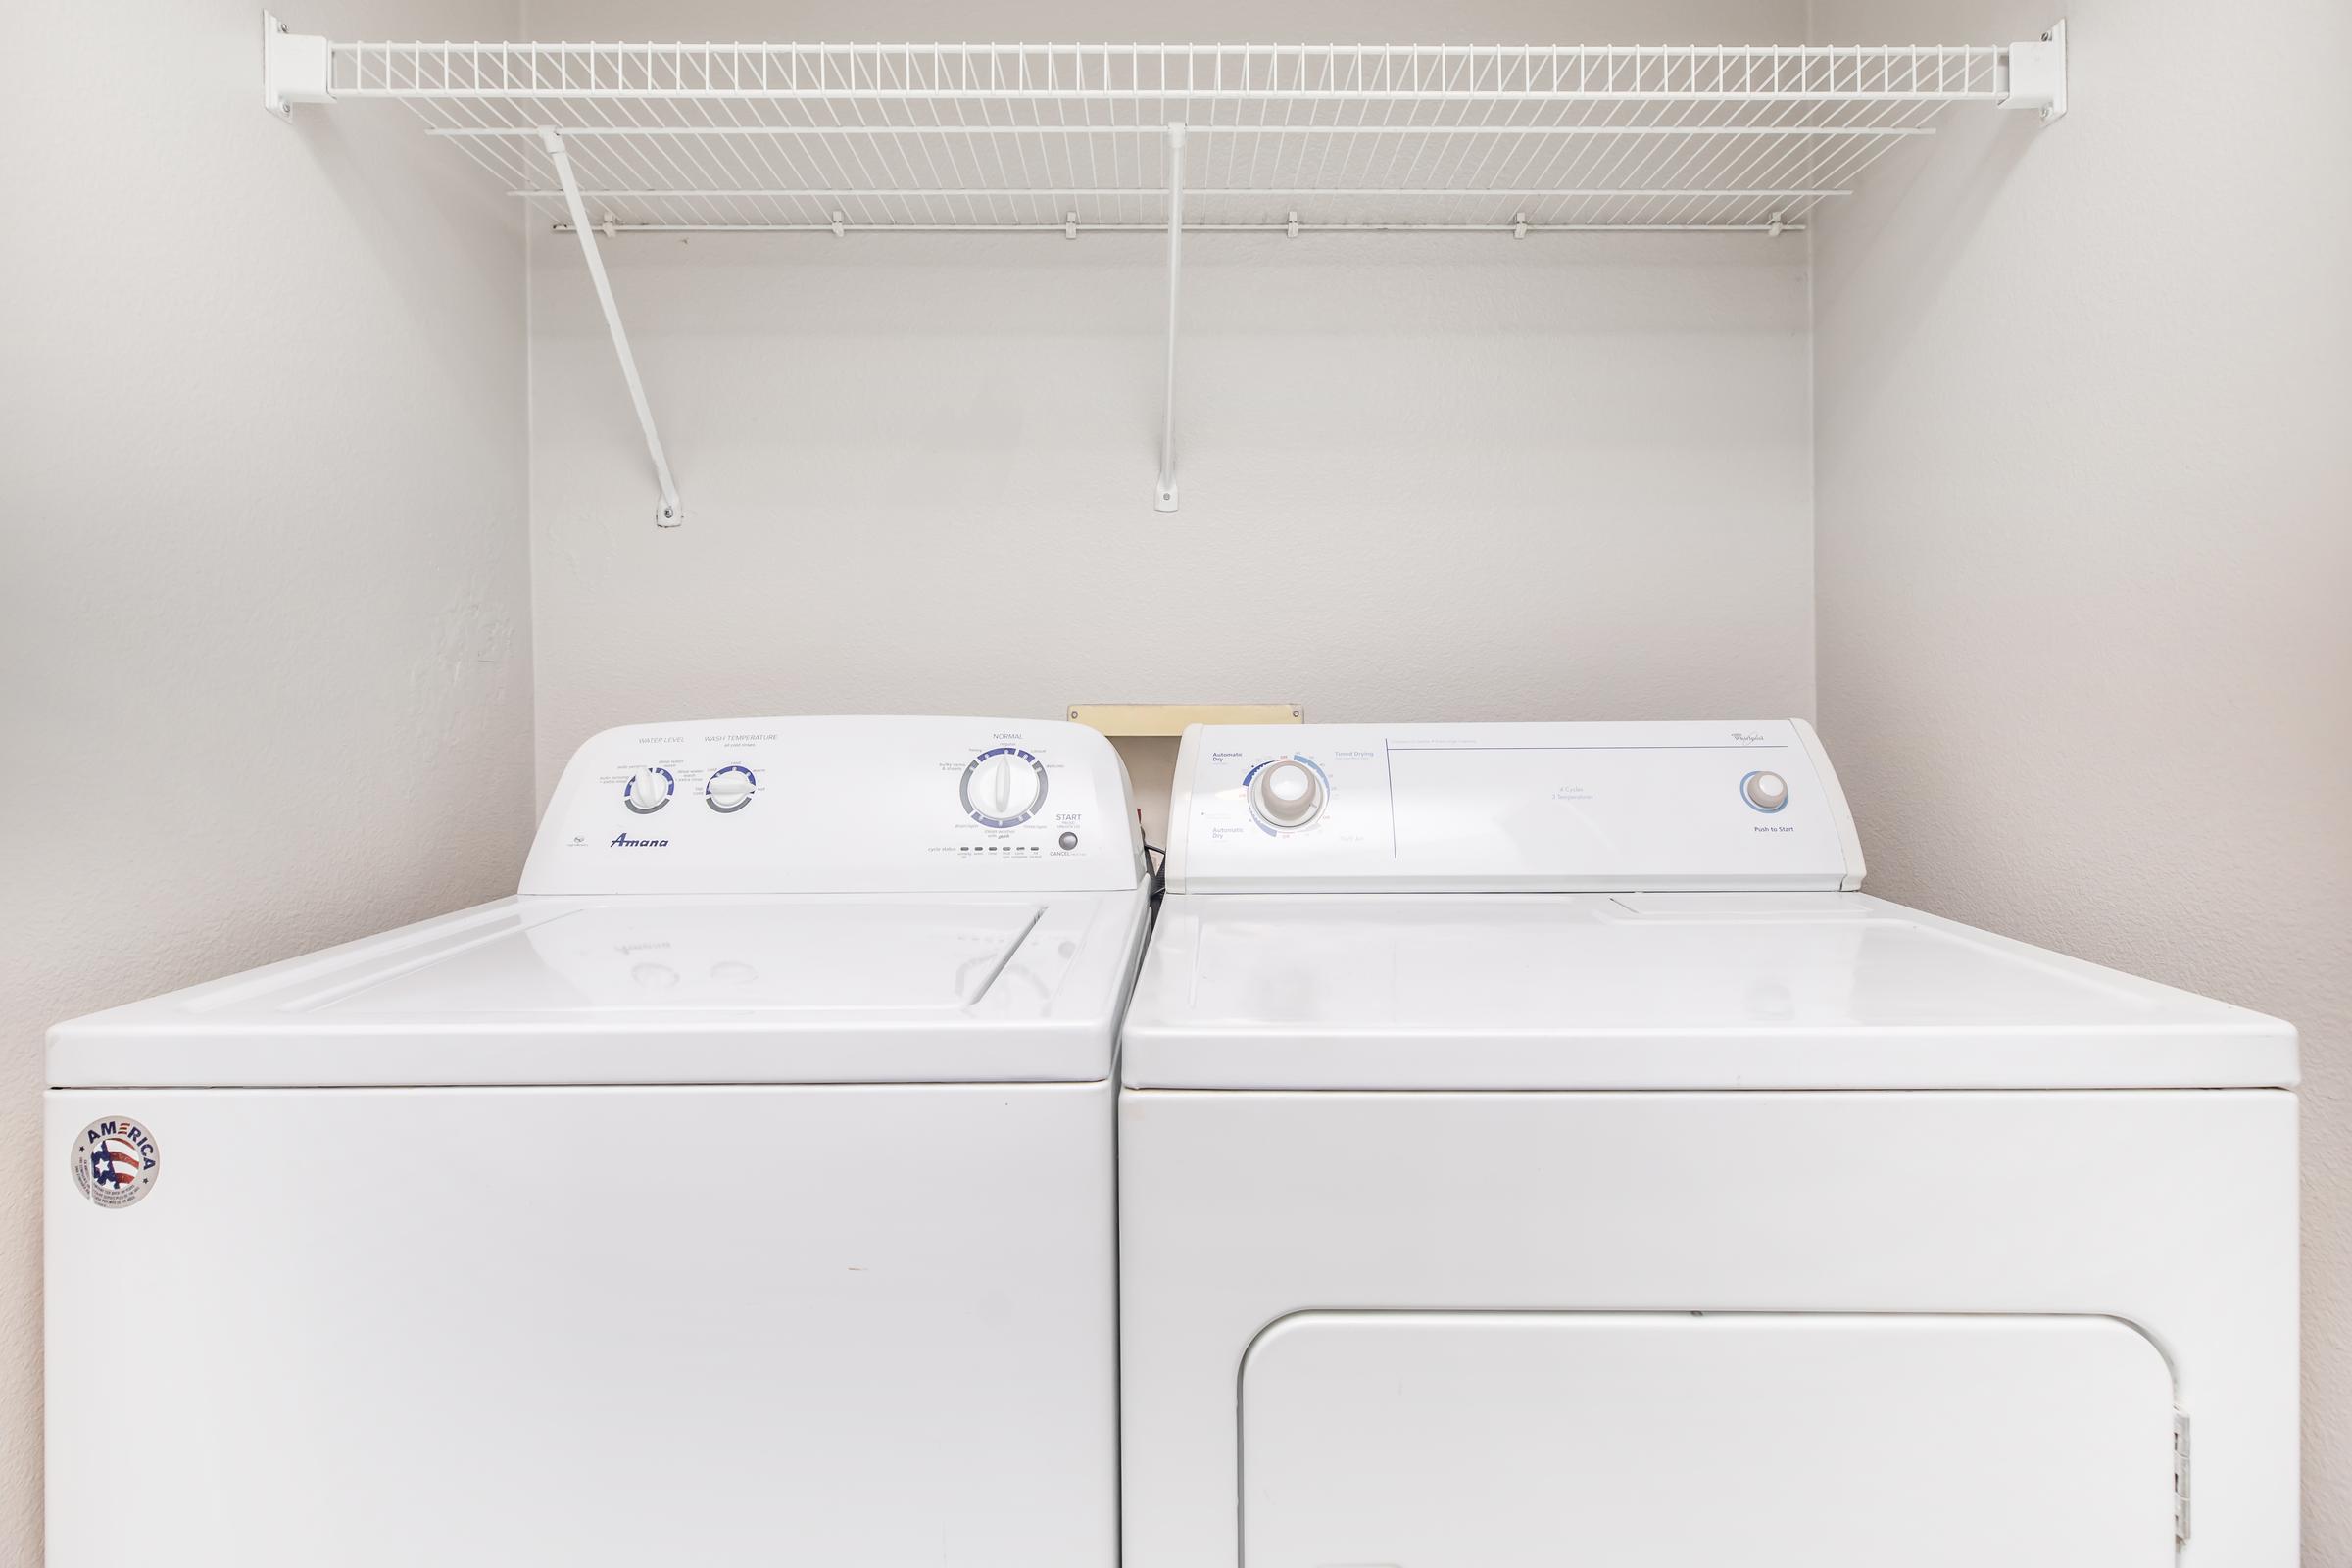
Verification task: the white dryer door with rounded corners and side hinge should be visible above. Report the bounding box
[1242,1312,2176,1568]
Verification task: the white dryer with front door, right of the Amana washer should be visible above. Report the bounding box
[1119,721,2298,1568]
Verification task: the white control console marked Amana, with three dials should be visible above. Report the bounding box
[522,717,1143,894]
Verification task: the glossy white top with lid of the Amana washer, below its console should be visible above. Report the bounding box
[49,891,1146,1089]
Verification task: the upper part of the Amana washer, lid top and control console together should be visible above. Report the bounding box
[49,717,1148,1089]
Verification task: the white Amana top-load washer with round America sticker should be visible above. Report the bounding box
[42,719,1148,1568]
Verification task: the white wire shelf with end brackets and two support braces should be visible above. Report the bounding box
[261,12,2068,524]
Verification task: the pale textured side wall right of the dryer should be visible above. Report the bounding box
[1811,0,2352,1566]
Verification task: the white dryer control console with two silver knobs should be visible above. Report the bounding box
[1169,719,1863,894]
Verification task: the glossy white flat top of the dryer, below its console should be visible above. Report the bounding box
[1124,894,2295,1091]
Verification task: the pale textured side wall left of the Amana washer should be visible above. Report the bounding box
[0,0,534,1563]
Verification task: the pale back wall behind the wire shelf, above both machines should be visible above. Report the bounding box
[531,0,1811,813]
